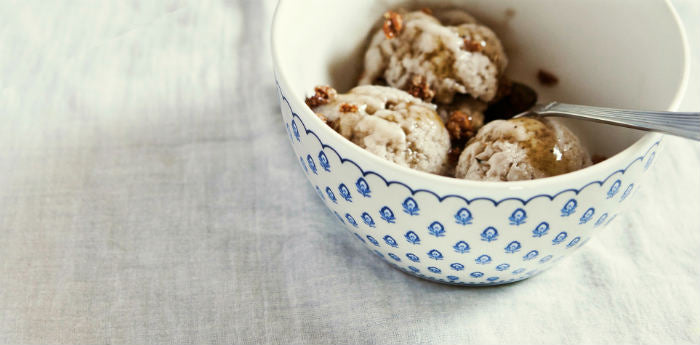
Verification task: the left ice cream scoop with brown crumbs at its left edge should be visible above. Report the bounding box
[307,85,450,174]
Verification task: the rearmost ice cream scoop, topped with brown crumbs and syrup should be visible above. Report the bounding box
[360,10,508,103]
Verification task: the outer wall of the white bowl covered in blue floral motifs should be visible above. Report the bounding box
[278,80,661,286]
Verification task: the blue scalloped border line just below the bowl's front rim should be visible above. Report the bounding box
[275,78,661,206]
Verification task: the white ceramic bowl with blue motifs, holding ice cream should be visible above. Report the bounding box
[273,0,687,285]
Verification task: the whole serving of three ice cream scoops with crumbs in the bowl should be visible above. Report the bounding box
[306,9,591,181]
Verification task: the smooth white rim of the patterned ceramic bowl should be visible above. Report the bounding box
[270,0,690,190]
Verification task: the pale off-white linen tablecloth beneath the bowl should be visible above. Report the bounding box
[0,0,700,344]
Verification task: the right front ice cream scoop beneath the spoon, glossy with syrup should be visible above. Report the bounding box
[455,117,591,181]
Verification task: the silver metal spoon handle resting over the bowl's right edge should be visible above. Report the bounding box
[532,102,700,141]
